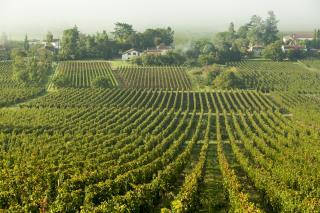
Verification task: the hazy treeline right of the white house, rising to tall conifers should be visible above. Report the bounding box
[133,11,281,66]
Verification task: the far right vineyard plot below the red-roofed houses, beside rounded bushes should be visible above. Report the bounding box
[230,61,320,92]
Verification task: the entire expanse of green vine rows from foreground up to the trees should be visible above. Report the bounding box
[0,61,320,213]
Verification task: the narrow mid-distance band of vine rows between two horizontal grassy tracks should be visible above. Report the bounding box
[21,89,279,112]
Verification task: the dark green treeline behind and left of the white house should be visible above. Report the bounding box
[59,23,174,60]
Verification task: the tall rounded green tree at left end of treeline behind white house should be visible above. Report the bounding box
[60,26,80,60]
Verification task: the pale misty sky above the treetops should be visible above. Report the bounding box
[0,0,320,38]
